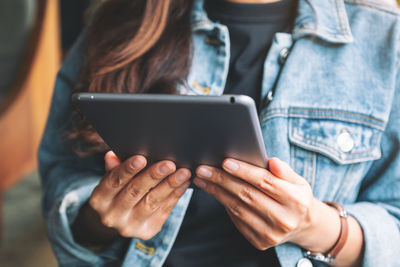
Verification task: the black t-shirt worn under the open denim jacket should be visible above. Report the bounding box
[164,0,297,267]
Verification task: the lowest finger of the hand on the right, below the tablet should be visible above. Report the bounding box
[194,178,280,247]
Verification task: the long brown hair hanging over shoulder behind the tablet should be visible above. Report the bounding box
[68,0,193,156]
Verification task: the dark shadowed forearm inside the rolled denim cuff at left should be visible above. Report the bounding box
[71,202,119,246]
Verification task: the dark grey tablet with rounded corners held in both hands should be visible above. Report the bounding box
[72,93,267,170]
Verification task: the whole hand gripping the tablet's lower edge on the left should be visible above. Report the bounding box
[89,151,191,240]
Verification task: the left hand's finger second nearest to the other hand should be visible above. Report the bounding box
[114,160,176,209]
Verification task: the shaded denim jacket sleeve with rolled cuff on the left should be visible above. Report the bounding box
[38,31,127,266]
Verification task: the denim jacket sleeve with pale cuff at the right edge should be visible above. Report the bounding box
[346,68,400,267]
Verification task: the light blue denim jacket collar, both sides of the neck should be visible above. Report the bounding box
[191,0,353,44]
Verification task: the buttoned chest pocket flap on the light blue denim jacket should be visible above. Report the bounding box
[289,108,384,164]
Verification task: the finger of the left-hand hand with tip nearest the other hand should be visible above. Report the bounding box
[134,169,191,217]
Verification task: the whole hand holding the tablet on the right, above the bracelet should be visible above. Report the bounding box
[194,158,316,250]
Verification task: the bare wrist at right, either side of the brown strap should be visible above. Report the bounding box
[295,200,364,266]
